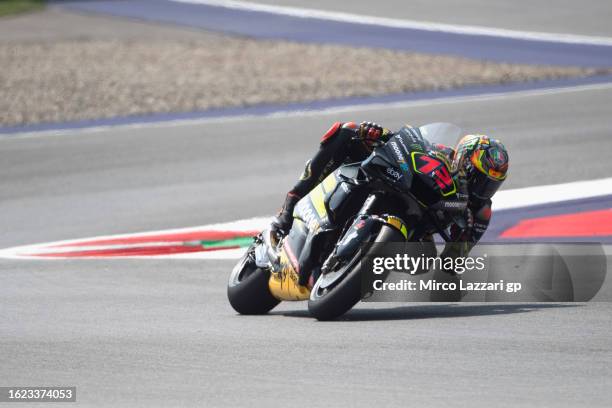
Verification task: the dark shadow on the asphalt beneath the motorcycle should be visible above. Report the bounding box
[270,303,582,321]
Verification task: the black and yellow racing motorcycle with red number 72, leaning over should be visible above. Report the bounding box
[227,123,466,320]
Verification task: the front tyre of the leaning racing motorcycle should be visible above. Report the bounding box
[308,226,404,320]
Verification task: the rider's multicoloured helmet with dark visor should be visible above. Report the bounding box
[452,135,508,200]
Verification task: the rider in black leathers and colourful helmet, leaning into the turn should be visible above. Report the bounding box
[272,122,508,278]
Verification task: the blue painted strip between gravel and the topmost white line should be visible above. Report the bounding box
[57,0,612,68]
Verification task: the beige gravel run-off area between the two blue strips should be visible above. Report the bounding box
[0,9,605,126]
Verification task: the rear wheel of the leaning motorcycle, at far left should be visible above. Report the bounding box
[227,246,280,315]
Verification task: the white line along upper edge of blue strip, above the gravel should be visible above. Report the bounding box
[172,0,612,46]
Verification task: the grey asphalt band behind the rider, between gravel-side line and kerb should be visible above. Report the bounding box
[0,85,612,248]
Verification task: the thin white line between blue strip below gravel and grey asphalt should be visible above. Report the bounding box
[0,82,612,143]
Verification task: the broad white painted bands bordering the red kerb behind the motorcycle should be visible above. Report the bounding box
[0,178,612,260]
